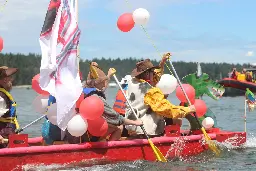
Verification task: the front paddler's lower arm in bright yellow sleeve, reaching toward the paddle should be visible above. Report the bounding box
[144,87,195,118]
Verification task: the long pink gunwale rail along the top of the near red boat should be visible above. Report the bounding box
[0,133,216,157]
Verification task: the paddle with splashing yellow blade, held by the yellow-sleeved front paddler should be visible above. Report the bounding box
[169,60,220,155]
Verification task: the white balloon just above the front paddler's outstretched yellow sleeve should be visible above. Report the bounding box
[156,74,178,95]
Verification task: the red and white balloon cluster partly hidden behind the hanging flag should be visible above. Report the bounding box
[32,74,108,137]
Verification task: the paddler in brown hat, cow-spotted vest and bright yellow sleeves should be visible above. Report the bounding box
[126,55,195,138]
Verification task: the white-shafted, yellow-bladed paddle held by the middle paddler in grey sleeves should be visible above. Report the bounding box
[113,74,167,162]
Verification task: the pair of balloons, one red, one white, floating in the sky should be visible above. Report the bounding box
[117,8,150,32]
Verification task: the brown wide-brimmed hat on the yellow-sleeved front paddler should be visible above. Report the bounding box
[131,59,160,77]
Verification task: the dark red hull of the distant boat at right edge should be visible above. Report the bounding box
[218,78,256,92]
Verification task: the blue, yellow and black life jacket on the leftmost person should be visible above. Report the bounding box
[0,88,19,130]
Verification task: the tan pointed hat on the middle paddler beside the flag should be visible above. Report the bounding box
[86,62,108,90]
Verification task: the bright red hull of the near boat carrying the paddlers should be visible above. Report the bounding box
[0,131,246,171]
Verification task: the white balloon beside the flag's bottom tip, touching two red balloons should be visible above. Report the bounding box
[67,114,88,137]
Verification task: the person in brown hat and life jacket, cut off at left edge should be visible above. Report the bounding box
[0,66,19,148]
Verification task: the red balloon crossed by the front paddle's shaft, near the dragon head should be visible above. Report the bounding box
[176,84,196,104]
